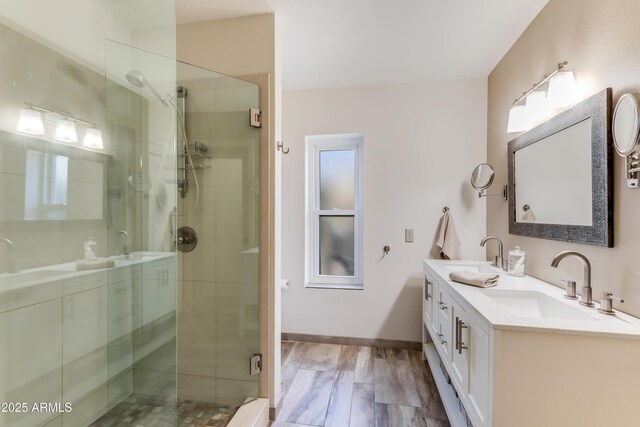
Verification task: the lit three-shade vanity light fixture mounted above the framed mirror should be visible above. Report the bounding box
[507,61,576,133]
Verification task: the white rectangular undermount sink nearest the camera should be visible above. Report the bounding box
[481,289,599,321]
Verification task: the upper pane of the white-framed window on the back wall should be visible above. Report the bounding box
[320,150,356,210]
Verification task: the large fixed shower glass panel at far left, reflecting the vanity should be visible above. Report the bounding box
[0,0,177,427]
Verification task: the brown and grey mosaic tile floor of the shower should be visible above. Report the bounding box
[89,395,236,427]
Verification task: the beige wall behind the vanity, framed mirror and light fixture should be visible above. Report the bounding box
[487,0,640,316]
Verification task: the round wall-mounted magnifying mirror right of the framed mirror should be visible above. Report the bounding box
[612,93,640,188]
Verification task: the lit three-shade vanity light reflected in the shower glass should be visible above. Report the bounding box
[16,102,104,150]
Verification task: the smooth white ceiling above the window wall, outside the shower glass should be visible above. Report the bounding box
[176,0,548,90]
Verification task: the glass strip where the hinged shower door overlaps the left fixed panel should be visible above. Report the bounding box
[104,38,177,427]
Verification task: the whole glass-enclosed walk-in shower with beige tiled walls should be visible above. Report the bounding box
[0,10,260,427]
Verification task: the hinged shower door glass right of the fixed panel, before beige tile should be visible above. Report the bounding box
[176,62,260,412]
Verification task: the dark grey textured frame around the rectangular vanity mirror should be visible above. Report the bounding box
[507,88,613,248]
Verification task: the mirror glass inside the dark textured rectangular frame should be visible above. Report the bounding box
[515,118,592,225]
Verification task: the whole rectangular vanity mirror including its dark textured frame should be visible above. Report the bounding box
[508,88,613,247]
